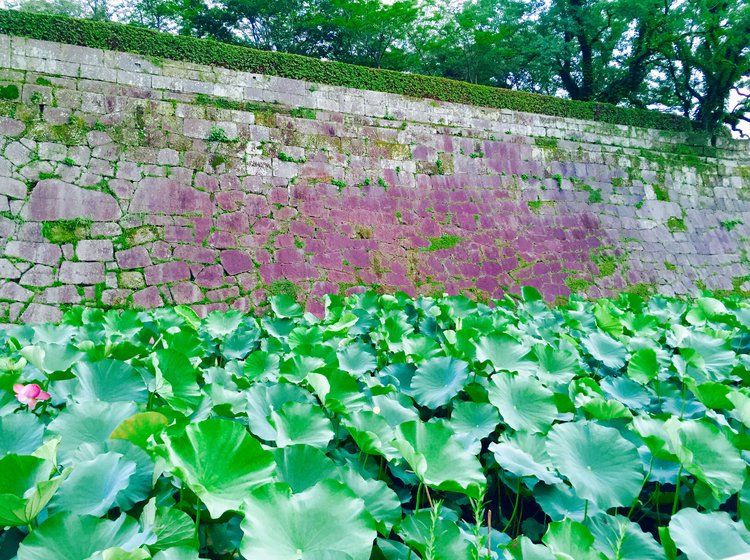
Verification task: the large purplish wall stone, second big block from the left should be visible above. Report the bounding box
[129,177,213,215]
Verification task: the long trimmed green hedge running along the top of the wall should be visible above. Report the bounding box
[0,10,691,131]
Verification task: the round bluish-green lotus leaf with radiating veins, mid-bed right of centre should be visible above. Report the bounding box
[411,358,469,408]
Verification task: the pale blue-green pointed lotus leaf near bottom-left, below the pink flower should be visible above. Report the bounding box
[50,452,136,517]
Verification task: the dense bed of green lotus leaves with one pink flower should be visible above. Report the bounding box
[0,289,750,560]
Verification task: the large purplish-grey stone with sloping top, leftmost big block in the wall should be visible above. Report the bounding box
[28,179,122,222]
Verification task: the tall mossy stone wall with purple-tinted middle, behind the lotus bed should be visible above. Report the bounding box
[0,36,750,322]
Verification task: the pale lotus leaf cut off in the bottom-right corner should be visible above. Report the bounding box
[669,508,750,560]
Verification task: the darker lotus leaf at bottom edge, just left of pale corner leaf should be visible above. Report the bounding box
[588,514,666,560]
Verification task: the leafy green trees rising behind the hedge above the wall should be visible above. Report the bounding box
[5,0,750,133]
